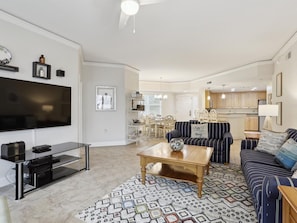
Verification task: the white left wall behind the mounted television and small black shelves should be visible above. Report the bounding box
[0,12,81,186]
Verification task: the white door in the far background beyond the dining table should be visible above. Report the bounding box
[175,95,194,121]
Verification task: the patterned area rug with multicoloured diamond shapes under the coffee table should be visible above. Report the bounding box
[76,164,257,223]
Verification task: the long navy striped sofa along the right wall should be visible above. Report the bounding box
[240,129,297,223]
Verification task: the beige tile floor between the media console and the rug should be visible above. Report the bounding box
[0,139,240,223]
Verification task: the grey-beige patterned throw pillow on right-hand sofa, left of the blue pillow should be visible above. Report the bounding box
[255,130,288,155]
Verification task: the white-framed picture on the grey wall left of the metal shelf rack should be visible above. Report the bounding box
[96,86,116,111]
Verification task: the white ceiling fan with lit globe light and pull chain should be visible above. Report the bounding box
[119,0,164,32]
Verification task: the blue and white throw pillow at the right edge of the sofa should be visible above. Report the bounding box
[275,138,297,170]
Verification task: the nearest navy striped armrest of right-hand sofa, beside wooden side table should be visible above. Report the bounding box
[261,176,297,223]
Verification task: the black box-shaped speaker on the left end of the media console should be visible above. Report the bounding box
[1,141,25,162]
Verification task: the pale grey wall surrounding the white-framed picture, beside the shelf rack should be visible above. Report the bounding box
[83,63,138,146]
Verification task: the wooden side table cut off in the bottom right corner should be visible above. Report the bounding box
[278,186,297,223]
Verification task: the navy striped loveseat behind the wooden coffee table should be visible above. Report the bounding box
[166,120,233,163]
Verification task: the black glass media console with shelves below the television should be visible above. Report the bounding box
[6,142,90,200]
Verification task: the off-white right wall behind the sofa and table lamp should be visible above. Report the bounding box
[272,38,297,131]
